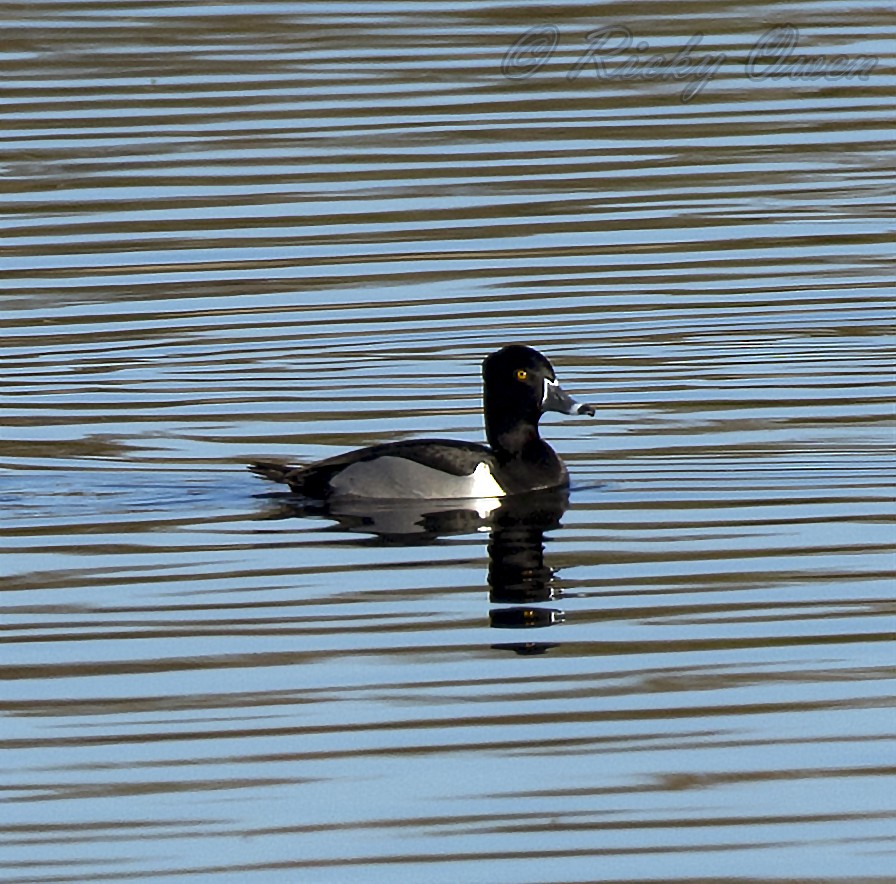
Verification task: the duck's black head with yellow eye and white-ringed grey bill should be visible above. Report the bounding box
[482,344,594,449]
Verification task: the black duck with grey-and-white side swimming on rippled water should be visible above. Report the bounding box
[249,344,595,501]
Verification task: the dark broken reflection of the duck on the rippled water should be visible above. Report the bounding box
[260,488,569,654]
